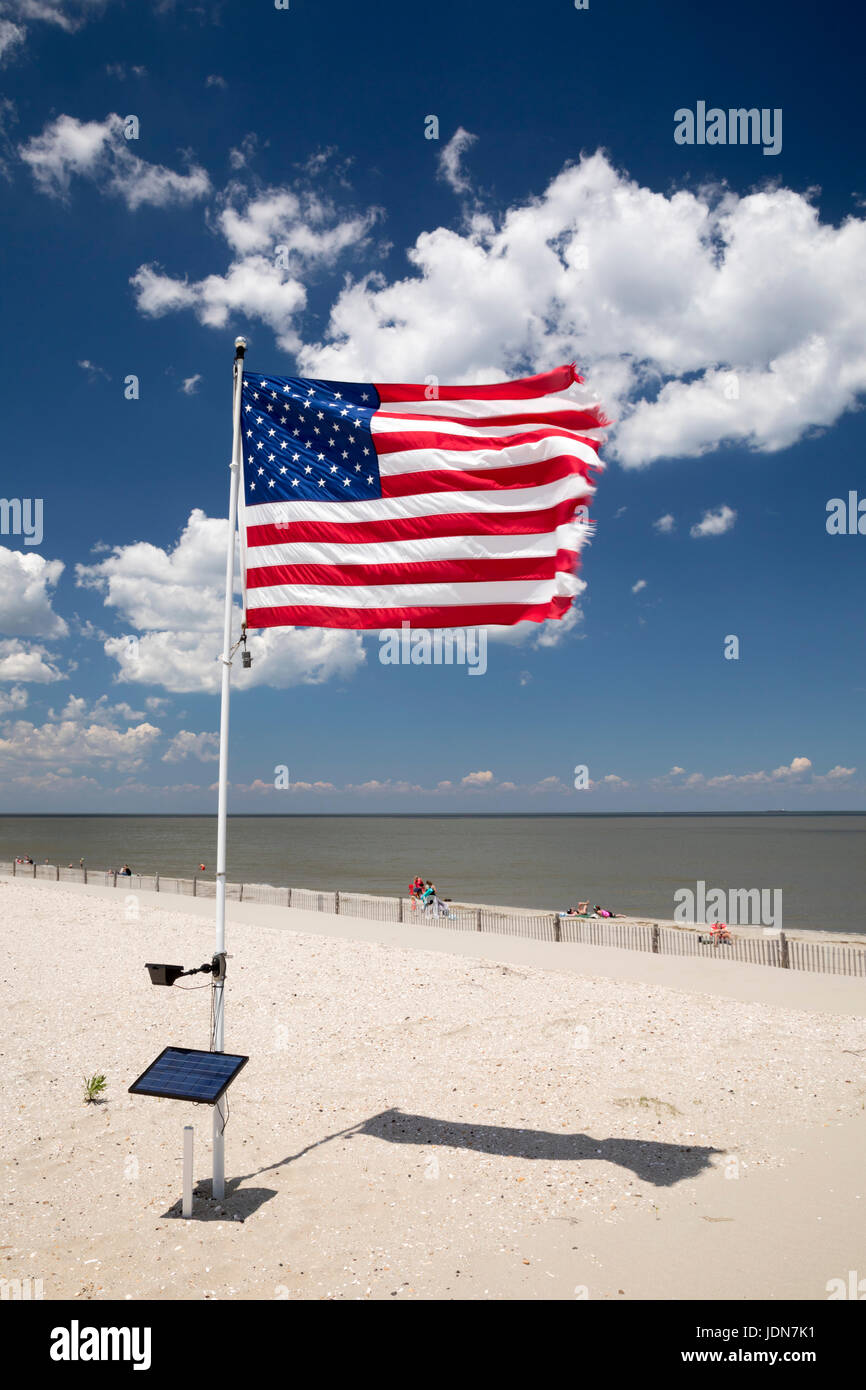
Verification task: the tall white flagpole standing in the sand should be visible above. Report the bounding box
[211,338,246,1201]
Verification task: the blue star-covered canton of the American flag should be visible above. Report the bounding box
[240,371,382,507]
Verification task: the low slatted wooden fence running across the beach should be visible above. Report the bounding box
[0,862,866,979]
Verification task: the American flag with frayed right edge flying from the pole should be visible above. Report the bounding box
[234,366,606,628]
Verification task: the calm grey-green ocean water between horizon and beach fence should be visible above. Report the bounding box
[0,815,866,935]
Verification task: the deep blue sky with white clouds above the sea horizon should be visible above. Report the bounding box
[0,0,866,812]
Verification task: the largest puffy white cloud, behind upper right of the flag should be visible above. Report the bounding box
[287,153,866,467]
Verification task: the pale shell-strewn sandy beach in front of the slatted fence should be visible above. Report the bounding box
[0,880,866,1301]
